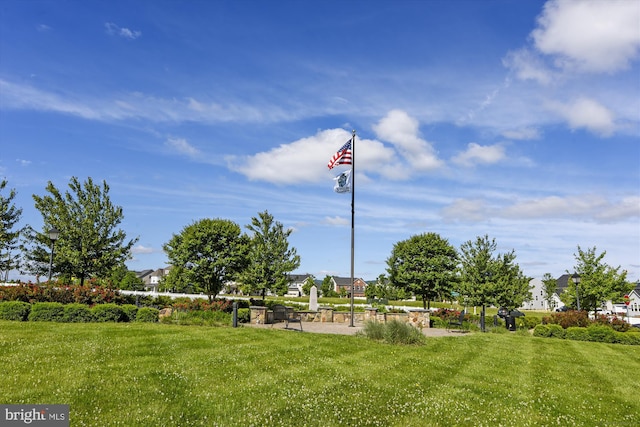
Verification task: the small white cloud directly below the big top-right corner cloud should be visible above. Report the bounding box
[550,98,615,136]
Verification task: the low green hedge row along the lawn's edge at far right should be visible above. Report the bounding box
[533,324,640,345]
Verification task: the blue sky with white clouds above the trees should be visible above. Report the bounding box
[0,0,640,280]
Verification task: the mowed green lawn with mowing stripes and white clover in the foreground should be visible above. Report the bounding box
[0,321,640,426]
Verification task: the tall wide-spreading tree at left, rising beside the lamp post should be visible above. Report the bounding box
[25,177,138,284]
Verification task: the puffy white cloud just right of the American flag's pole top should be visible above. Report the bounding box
[373,110,443,171]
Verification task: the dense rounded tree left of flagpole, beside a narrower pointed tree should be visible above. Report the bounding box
[163,218,247,301]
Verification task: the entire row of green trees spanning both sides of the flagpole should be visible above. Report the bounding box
[0,177,630,309]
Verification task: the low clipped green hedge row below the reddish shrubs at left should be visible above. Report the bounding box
[0,301,159,323]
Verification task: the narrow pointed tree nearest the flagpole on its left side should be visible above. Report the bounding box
[241,211,300,300]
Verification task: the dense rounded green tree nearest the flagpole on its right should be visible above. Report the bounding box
[387,233,458,309]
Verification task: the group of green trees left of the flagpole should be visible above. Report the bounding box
[0,177,300,298]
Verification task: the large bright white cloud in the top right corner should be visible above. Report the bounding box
[531,0,640,72]
